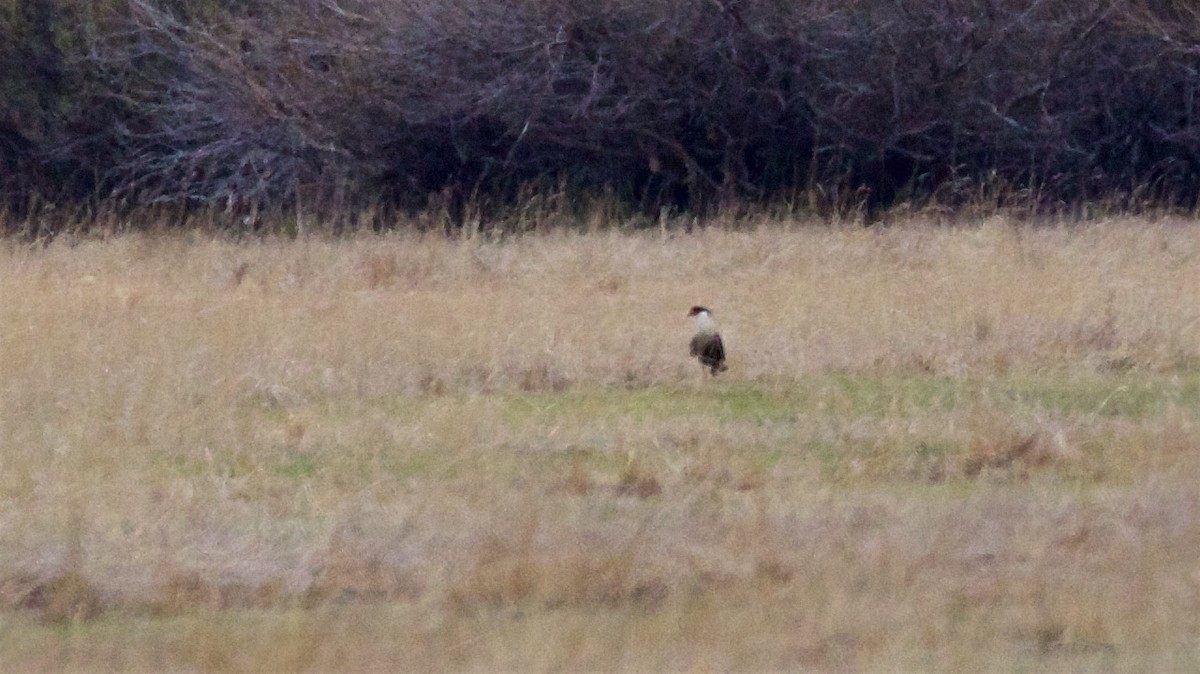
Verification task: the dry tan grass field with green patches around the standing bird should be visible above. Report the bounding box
[0,218,1200,672]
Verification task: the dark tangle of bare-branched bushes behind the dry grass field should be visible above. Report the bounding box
[0,0,1200,227]
